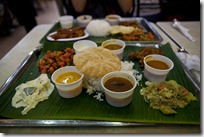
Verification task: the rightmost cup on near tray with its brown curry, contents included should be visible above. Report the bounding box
[143,54,174,82]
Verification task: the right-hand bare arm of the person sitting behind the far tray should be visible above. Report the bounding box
[118,0,134,13]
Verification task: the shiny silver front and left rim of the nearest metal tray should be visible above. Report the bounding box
[0,46,200,128]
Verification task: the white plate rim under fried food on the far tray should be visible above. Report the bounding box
[47,31,89,41]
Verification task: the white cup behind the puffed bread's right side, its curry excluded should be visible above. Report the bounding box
[101,39,126,60]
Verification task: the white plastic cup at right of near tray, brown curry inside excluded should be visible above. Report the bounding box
[143,54,174,82]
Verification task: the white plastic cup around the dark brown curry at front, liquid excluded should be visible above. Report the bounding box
[101,71,137,107]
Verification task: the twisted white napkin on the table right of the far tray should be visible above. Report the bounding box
[172,19,195,41]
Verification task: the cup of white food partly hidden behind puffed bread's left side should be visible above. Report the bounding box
[73,40,97,54]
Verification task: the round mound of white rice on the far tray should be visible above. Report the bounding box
[86,20,111,37]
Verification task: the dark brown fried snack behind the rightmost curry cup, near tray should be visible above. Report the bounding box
[128,47,163,67]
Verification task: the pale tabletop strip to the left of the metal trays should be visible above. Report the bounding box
[0,24,52,86]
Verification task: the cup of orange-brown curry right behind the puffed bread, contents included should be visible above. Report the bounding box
[101,39,126,60]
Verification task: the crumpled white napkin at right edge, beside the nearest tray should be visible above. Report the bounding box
[176,52,200,82]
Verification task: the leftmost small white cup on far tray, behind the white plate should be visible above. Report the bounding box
[59,15,74,29]
